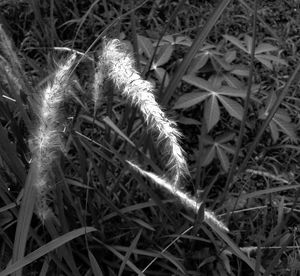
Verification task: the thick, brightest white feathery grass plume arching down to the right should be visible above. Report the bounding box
[100,39,189,187]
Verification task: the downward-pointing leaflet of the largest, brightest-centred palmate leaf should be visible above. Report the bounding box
[204,95,220,132]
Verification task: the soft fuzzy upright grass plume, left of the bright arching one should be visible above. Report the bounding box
[32,53,76,220]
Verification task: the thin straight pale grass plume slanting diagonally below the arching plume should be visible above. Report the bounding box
[127,161,229,232]
